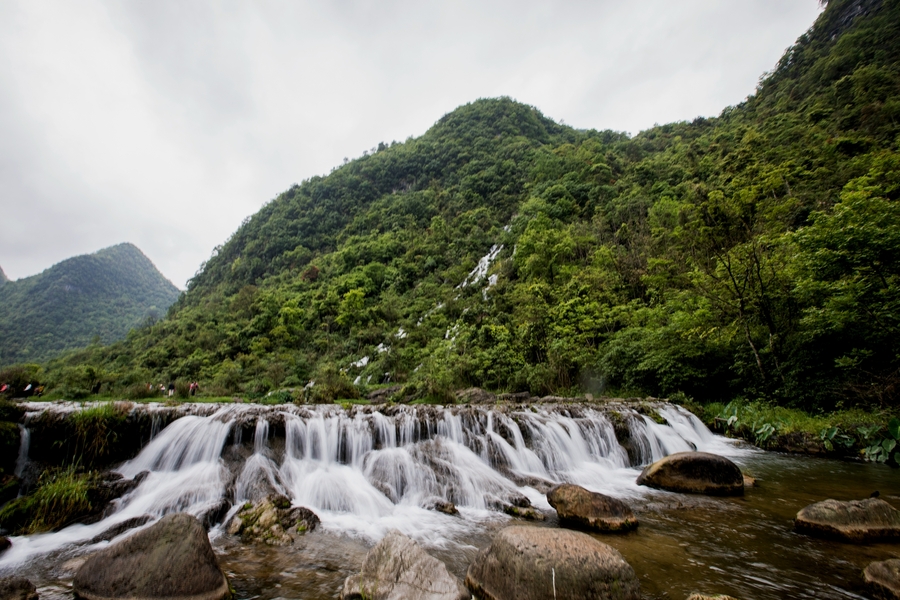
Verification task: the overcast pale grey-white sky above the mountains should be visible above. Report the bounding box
[0,0,820,289]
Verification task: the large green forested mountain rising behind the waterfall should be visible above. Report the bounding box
[47,0,900,408]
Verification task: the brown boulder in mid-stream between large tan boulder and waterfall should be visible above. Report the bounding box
[547,483,638,531]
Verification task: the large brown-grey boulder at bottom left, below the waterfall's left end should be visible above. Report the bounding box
[73,513,231,600]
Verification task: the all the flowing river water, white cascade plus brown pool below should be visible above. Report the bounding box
[0,404,900,600]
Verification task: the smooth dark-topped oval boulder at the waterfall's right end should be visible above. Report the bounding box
[637,452,744,496]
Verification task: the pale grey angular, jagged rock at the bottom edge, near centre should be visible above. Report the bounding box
[341,530,469,600]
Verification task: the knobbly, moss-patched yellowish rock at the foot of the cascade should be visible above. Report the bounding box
[226,495,319,546]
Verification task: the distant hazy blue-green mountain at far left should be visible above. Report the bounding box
[0,244,180,365]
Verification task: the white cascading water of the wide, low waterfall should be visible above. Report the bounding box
[0,405,746,574]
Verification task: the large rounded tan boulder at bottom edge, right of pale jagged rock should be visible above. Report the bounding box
[466,526,640,600]
